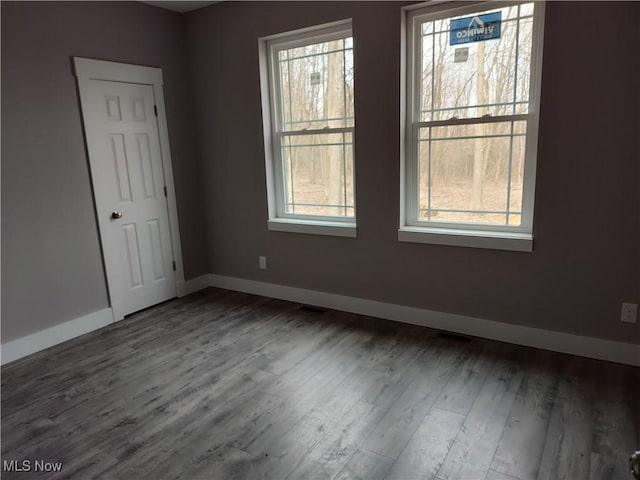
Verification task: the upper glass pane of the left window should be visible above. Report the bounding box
[278,37,354,131]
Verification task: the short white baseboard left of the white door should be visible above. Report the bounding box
[1,308,113,365]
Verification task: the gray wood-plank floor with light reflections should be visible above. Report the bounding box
[2,289,640,480]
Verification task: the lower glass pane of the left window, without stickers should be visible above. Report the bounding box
[282,132,355,217]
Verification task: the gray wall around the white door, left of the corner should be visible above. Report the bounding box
[1,1,207,343]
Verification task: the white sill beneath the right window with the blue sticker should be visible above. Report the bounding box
[398,227,533,252]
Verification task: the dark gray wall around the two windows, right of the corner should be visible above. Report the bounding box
[187,2,640,343]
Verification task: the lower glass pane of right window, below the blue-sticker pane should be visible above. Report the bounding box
[418,121,526,225]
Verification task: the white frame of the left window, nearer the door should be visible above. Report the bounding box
[258,19,357,238]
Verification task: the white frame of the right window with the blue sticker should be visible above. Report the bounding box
[398,1,545,252]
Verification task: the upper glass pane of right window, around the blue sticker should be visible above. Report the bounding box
[419,4,534,121]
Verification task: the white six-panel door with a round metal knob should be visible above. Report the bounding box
[80,73,176,319]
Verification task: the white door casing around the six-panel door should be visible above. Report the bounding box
[73,57,185,322]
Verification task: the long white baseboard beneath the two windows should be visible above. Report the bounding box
[209,274,640,367]
